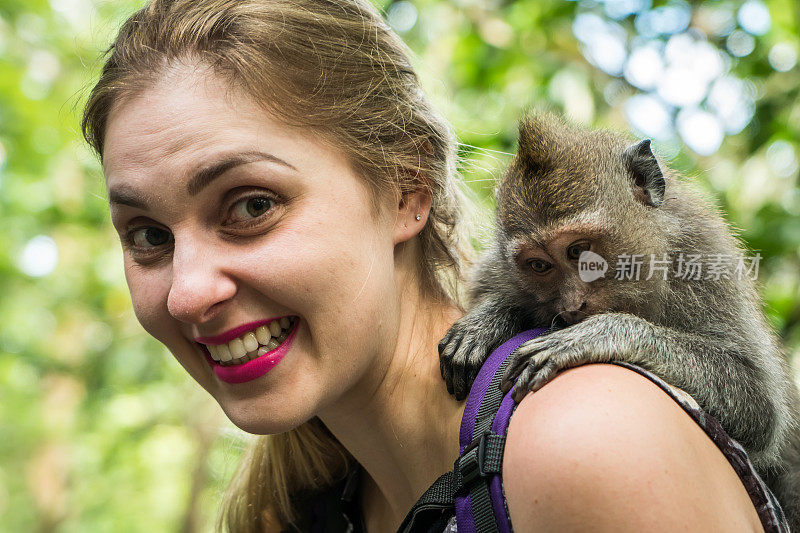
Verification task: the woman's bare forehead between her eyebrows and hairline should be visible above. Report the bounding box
[103,72,320,179]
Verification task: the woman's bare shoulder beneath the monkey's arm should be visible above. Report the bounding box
[503,364,761,531]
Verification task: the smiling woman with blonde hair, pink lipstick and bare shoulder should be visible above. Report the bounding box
[83,0,780,532]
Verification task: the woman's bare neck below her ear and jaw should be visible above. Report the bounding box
[320,282,464,530]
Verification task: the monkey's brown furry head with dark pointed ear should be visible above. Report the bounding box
[497,115,669,324]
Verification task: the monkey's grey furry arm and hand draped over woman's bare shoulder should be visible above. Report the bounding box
[502,313,788,463]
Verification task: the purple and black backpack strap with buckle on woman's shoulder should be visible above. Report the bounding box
[454,328,546,533]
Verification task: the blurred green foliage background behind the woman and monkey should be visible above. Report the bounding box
[0,0,800,532]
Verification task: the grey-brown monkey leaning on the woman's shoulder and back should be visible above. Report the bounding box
[439,113,800,531]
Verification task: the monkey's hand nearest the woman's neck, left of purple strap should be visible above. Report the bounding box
[439,293,525,400]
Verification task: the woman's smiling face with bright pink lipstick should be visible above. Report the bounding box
[103,68,406,433]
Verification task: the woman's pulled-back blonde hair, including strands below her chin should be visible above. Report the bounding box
[82,0,472,532]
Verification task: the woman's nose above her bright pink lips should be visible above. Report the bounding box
[167,239,236,324]
